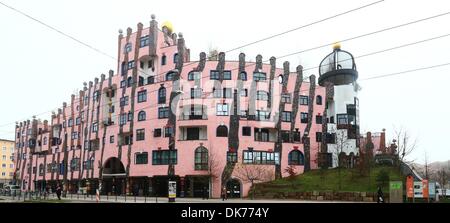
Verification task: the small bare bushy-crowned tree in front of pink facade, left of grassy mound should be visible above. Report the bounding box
[235,163,275,199]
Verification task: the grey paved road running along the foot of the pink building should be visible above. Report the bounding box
[0,195,358,203]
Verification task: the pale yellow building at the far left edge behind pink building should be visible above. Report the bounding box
[0,139,15,184]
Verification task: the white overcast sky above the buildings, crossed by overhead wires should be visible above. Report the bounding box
[0,0,450,162]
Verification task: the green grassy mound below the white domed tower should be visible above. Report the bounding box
[256,167,403,193]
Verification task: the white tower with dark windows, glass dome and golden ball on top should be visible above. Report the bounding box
[319,44,360,167]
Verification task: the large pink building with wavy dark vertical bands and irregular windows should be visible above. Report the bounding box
[12,16,357,197]
